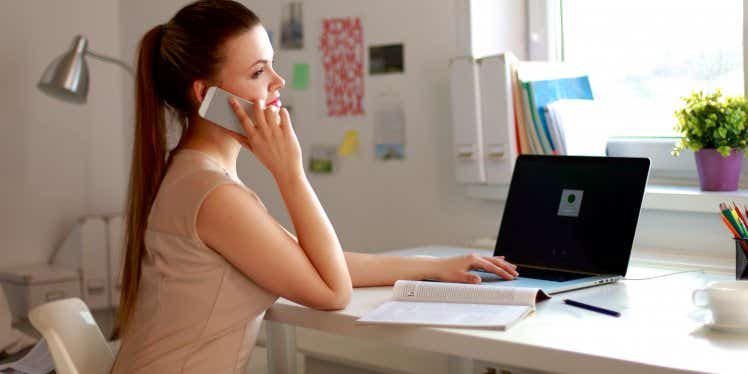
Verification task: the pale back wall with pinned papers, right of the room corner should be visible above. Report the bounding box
[122,0,501,254]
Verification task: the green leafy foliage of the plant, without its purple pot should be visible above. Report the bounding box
[672,89,748,157]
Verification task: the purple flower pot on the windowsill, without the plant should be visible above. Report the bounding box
[694,148,743,191]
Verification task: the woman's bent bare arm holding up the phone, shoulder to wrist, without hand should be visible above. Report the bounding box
[197,180,352,310]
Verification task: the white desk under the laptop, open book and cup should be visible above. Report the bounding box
[266,247,748,373]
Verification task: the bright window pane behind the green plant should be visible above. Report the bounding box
[557,0,744,137]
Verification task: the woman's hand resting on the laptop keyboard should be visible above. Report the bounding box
[426,253,519,283]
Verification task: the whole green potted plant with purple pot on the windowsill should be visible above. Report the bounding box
[673,89,748,191]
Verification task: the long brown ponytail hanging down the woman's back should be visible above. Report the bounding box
[113,25,167,336]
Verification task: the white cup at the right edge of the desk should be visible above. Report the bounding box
[692,280,748,327]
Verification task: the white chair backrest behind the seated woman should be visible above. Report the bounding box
[29,298,114,374]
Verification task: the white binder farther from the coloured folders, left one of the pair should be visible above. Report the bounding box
[449,57,486,183]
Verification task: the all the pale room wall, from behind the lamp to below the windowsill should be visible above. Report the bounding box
[0,0,731,267]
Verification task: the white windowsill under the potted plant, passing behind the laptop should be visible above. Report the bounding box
[466,185,748,213]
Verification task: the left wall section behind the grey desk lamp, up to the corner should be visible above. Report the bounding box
[0,0,124,267]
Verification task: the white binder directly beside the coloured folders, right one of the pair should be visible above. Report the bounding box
[478,52,518,184]
